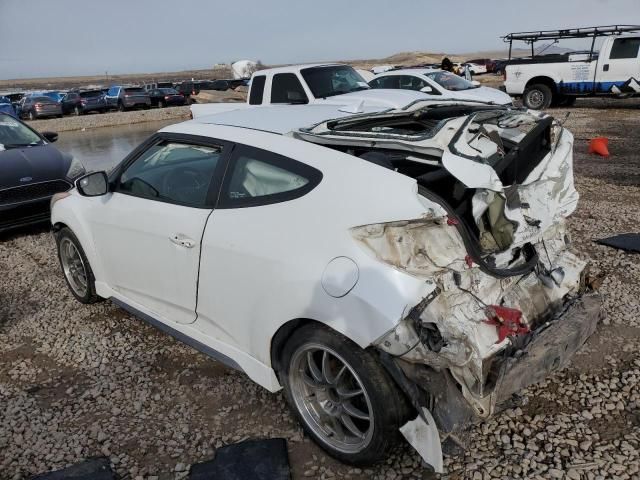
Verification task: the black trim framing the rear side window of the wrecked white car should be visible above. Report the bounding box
[216,143,323,209]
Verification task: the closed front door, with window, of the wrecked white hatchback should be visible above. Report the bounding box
[90,134,227,323]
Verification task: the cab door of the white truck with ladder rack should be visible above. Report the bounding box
[596,37,640,94]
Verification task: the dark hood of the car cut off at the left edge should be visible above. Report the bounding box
[0,144,71,189]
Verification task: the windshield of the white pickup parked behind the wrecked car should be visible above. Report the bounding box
[300,65,370,98]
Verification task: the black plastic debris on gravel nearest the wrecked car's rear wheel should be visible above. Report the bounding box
[188,438,291,480]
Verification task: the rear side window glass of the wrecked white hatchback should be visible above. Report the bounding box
[220,145,322,208]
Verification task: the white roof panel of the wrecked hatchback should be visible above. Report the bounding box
[178,104,388,135]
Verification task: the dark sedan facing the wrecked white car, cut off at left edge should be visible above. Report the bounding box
[0,113,85,231]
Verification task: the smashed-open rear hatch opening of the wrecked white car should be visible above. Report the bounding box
[298,105,564,277]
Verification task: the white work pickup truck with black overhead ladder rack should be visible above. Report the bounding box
[503,25,640,110]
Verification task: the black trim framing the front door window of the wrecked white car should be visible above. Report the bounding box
[108,132,234,210]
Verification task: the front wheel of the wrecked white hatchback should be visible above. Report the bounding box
[55,227,102,304]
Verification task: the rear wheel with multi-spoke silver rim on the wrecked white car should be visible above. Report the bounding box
[278,324,411,466]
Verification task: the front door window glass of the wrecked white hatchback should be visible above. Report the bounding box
[117,141,222,208]
